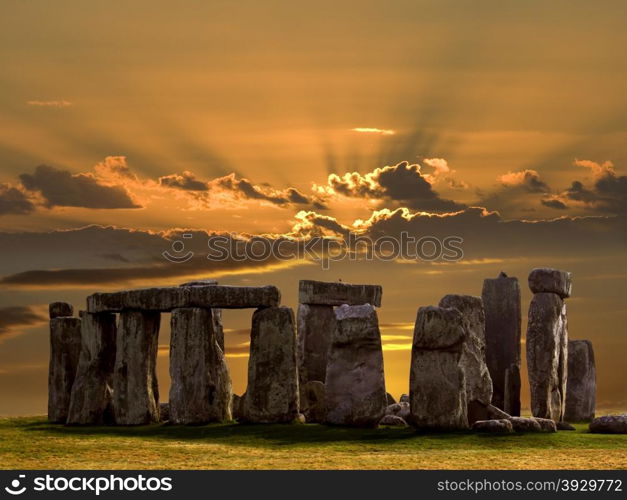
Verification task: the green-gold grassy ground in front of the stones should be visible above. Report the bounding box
[0,417,627,469]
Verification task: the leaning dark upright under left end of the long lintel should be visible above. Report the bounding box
[67,311,117,425]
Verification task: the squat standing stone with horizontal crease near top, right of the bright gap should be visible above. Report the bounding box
[409,306,468,429]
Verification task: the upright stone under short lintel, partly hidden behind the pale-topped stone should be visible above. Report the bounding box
[298,304,335,387]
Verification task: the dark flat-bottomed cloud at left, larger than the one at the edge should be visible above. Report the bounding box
[20,165,141,209]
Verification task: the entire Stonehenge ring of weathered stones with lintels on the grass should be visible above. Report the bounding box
[48,268,604,433]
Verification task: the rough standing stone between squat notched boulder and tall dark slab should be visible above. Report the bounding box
[439,295,492,424]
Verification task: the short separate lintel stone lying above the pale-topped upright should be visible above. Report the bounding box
[298,280,383,307]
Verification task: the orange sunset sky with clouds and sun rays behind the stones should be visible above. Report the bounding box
[0,0,627,415]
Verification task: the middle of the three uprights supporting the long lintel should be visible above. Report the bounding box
[113,311,161,425]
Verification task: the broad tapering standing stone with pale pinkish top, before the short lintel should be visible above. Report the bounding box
[325,304,387,427]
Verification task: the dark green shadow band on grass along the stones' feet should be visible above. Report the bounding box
[13,419,612,451]
